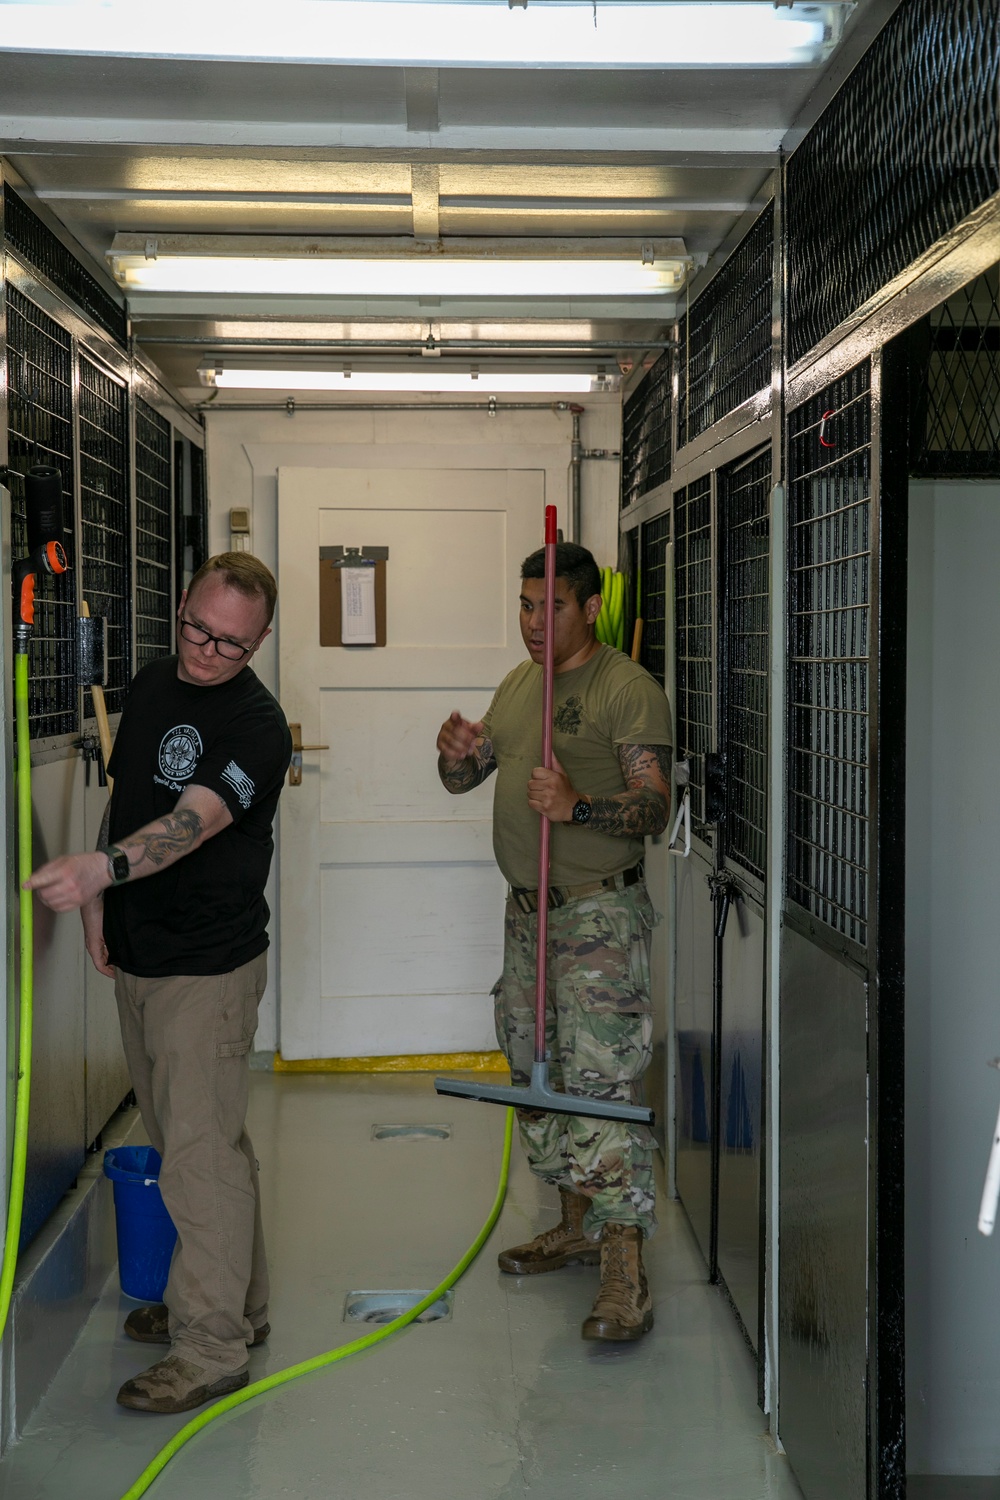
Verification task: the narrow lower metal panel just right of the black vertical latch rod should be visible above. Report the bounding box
[718,900,765,1350]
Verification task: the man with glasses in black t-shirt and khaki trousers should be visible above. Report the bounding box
[27,552,291,1412]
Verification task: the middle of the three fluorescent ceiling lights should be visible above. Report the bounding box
[108,234,690,300]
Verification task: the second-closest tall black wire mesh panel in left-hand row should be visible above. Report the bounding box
[79,354,130,717]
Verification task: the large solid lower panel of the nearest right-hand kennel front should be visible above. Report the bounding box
[778,923,868,1500]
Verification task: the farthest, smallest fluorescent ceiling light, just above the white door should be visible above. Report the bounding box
[198,363,616,398]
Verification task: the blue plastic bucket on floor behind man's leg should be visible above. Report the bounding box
[103,1146,177,1302]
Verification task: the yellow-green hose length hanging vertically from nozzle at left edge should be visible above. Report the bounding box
[0,642,34,1334]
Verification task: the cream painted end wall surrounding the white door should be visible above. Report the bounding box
[205,396,621,1052]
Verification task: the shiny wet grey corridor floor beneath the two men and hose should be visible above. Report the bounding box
[0,1074,801,1500]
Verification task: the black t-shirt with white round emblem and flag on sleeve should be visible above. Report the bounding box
[103,657,291,978]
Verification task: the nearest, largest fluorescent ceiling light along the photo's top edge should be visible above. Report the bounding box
[0,0,853,69]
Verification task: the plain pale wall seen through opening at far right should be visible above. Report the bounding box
[906,482,1000,1475]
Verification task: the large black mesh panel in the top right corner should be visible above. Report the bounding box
[786,0,1000,362]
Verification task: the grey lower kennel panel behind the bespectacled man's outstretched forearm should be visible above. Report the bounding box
[18,756,87,1247]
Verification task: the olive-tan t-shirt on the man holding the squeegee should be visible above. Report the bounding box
[483,647,673,890]
